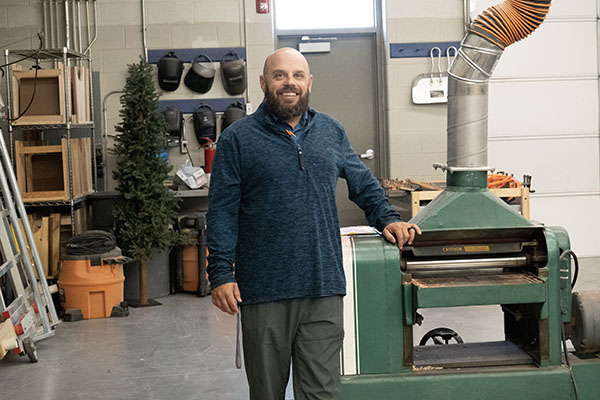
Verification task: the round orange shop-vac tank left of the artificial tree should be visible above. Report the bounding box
[58,248,125,319]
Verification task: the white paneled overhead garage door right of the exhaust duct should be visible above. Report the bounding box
[478,0,600,256]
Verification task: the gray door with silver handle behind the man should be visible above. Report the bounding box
[277,34,379,226]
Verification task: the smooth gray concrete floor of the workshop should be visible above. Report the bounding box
[0,258,600,400]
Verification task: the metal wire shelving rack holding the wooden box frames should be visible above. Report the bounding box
[4,47,97,233]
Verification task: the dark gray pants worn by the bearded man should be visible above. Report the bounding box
[242,296,344,400]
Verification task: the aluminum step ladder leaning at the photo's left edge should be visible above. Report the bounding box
[0,129,60,362]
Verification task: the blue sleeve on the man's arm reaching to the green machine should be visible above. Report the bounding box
[341,132,402,232]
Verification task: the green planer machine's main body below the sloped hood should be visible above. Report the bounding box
[342,220,600,400]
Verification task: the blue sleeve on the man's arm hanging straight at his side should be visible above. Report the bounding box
[206,132,241,289]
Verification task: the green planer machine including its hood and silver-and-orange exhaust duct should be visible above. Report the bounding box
[341,0,600,400]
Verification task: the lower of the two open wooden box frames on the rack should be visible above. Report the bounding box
[15,138,93,202]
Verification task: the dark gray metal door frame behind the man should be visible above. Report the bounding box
[273,0,390,179]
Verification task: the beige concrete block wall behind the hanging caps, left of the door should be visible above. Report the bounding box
[0,0,274,190]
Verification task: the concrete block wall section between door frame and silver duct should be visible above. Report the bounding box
[385,0,464,181]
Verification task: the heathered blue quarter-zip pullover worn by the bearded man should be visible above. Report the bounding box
[207,105,401,304]
